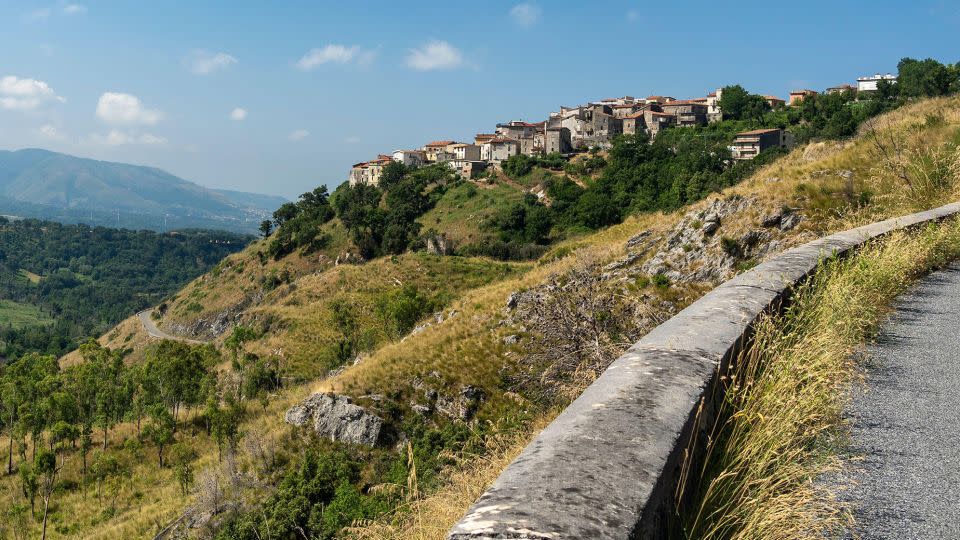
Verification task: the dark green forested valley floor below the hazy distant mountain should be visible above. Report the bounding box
[0,217,250,358]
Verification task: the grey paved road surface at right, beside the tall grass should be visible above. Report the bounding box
[844,265,960,540]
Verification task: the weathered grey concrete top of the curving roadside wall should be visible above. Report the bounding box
[449,203,960,540]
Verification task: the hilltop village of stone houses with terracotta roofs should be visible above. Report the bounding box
[349,73,897,185]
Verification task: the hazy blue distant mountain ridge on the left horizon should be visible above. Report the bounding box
[0,149,286,232]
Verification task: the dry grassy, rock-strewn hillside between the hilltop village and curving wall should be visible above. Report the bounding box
[0,90,960,538]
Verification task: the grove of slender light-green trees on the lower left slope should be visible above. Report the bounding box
[0,340,279,529]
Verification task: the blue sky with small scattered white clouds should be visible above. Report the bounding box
[0,0,960,198]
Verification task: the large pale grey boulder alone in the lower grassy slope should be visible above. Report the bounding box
[284,392,384,446]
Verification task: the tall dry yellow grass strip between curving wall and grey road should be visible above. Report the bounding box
[682,220,960,540]
